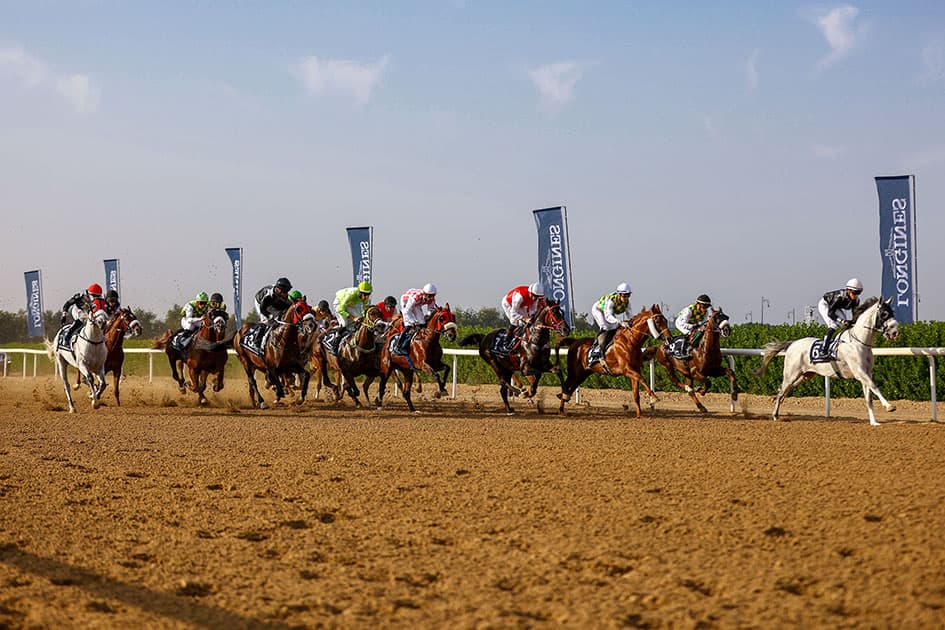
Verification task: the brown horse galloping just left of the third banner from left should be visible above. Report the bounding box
[151,309,230,405]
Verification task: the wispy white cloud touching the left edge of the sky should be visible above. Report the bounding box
[0,47,99,114]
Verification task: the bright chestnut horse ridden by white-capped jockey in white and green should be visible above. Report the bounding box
[555,304,670,418]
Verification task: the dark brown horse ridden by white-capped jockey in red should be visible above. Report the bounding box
[459,301,571,416]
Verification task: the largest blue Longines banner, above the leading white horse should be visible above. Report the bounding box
[876,175,918,324]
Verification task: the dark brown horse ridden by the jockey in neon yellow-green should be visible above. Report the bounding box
[311,306,389,408]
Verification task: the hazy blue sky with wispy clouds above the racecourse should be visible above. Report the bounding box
[0,0,945,322]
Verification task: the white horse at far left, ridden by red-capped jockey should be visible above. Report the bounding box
[43,309,108,413]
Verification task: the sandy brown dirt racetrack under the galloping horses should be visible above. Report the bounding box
[0,377,945,628]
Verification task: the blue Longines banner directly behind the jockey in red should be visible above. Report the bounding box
[532,206,574,326]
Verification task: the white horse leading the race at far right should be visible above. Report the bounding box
[760,297,899,426]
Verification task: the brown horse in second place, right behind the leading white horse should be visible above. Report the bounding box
[643,309,739,413]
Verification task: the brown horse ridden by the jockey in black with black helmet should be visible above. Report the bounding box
[233,304,310,409]
